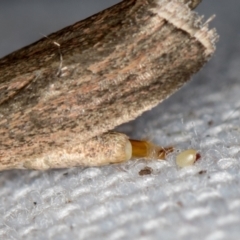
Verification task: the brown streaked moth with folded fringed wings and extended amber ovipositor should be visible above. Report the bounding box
[0,0,217,170]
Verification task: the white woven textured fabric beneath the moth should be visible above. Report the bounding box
[0,0,240,240]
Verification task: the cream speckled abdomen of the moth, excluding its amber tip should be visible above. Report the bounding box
[22,132,132,170]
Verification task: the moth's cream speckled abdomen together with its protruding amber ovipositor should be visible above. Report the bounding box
[21,132,172,170]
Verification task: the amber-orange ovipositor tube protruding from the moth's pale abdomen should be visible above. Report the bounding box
[129,139,173,160]
